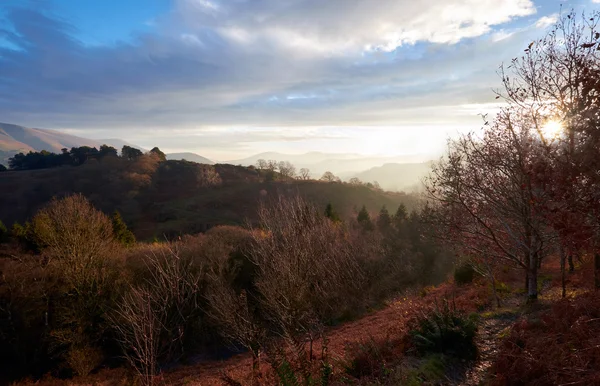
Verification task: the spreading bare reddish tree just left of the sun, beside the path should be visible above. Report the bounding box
[426,110,553,300]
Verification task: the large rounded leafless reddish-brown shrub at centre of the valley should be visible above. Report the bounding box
[250,196,363,358]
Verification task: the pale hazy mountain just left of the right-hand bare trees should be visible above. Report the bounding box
[353,161,432,191]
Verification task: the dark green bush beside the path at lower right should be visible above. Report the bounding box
[410,299,477,359]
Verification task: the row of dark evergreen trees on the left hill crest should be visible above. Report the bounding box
[8,145,167,170]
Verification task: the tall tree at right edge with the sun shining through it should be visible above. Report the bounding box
[498,11,600,286]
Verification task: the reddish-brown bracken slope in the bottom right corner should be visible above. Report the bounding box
[494,293,600,385]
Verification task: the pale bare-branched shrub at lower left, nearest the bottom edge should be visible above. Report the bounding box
[111,244,203,384]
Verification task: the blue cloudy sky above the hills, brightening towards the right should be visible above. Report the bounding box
[0,0,600,160]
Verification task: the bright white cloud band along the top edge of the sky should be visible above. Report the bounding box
[172,0,536,54]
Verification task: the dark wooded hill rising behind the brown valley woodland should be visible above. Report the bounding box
[0,153,417,239]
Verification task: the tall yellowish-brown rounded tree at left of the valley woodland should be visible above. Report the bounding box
[32,195,118,375]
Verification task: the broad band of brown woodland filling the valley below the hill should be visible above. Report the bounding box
[0,195,452,384]
